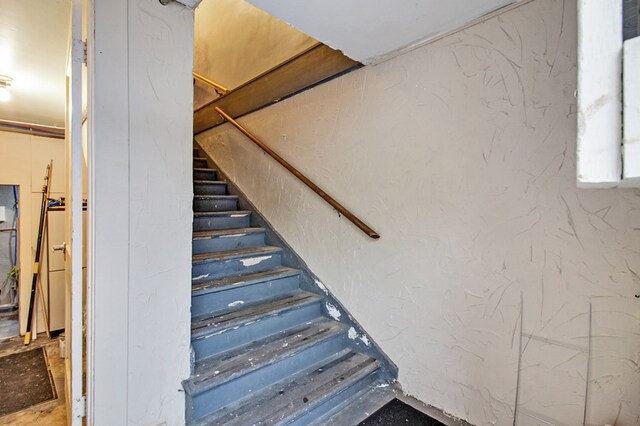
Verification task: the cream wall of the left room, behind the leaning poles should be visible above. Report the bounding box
[0,131,67,334]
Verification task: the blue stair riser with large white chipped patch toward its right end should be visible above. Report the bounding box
[191,252,282,284]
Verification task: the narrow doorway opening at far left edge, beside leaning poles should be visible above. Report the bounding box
[0,185,20,341]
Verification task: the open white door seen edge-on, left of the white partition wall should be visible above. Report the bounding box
[65,0,85,425]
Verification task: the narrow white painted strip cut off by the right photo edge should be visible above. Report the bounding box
[623,37,640,187]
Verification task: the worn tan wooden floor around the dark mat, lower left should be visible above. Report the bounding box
[0,336,67,426]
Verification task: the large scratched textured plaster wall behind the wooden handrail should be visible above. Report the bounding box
[198,0,640,425]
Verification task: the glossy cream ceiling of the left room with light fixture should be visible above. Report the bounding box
[0,0,71,127]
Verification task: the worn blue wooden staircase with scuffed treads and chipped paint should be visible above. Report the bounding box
[184,149,397,426]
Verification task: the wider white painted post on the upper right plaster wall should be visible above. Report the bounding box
[576,0,622,188]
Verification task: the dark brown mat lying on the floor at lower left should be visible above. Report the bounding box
[0,348,56,416]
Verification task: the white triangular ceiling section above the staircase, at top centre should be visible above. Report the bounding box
[248,0,516,64]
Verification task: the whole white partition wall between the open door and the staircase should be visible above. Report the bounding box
[87,0,193,425]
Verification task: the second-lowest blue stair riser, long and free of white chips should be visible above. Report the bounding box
[187,333,346,419]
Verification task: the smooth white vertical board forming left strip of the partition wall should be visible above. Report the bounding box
[87,0,129,425]
